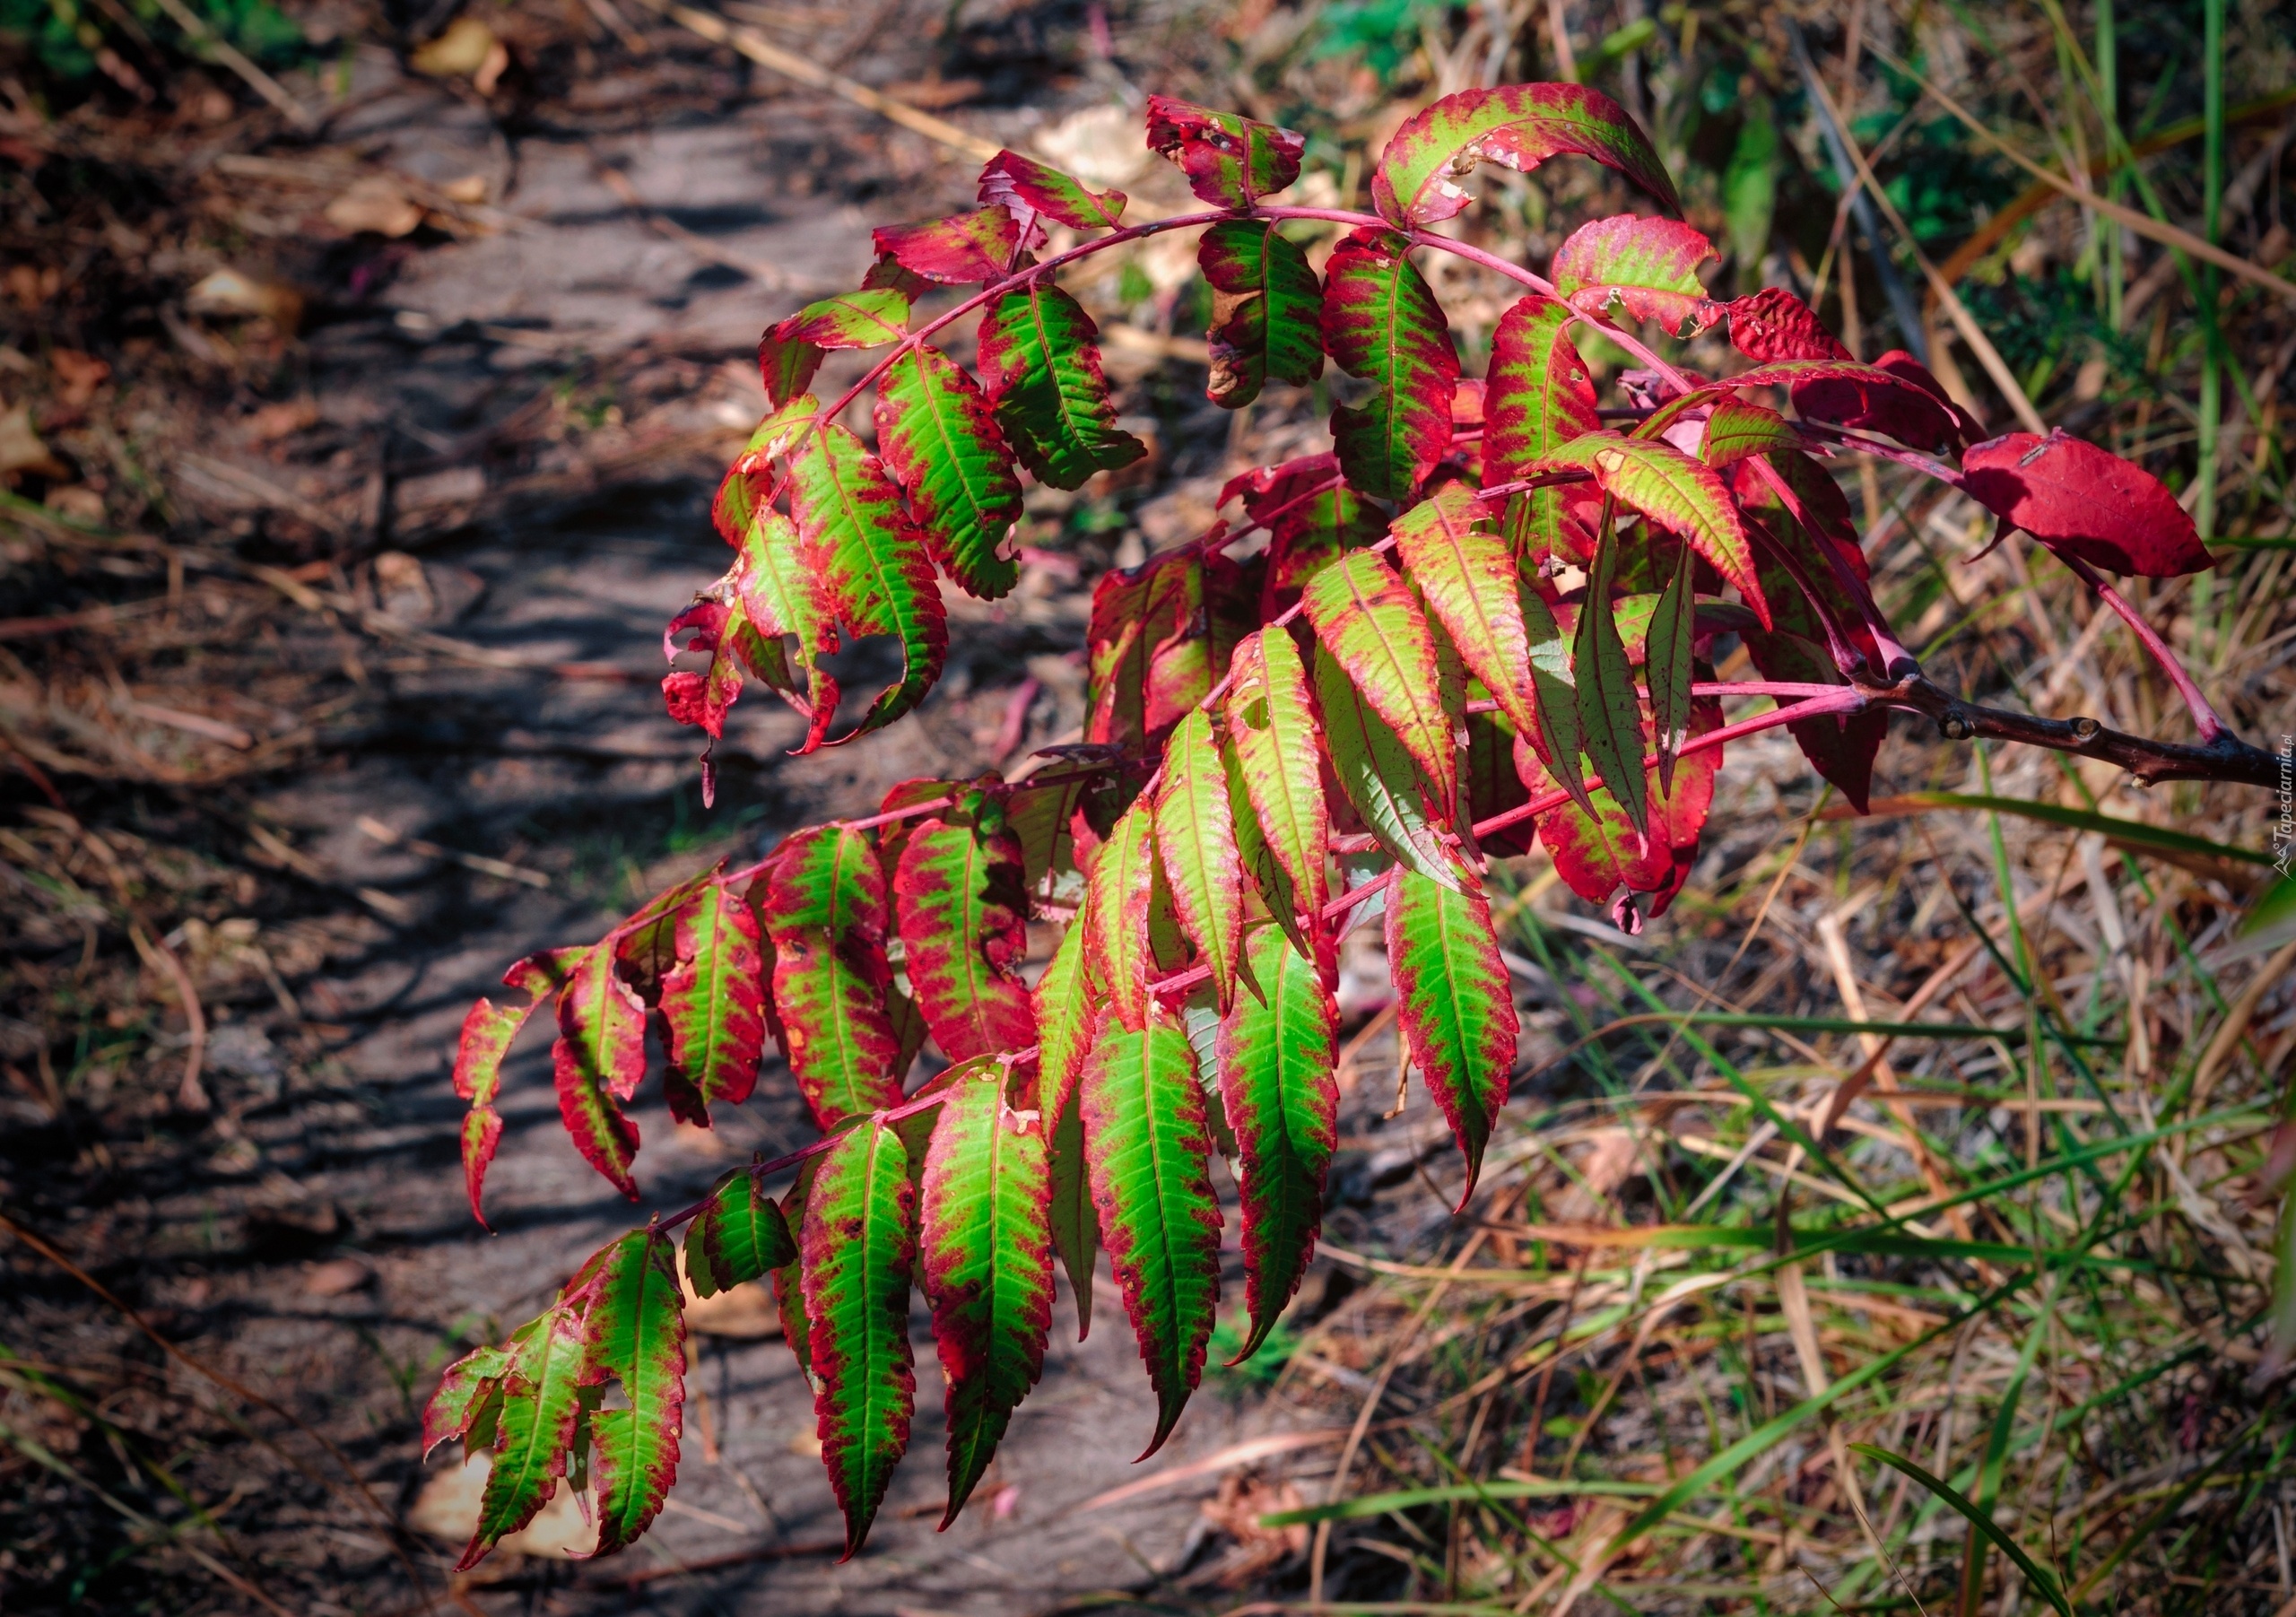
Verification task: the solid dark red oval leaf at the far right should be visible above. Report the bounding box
[1961,427,2213,578]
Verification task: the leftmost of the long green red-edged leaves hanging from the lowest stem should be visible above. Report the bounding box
[799,1121,916,1560]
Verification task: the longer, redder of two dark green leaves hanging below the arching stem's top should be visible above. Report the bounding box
[1323,228,1458,500]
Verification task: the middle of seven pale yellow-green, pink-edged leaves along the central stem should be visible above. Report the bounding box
[1223,630,1332,953]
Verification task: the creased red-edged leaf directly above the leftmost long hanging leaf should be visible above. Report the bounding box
[758,824,902,1127]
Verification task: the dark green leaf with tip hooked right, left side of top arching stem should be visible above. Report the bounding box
[980,280,1148,490]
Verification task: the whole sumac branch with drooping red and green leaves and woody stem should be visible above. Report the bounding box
[425,85,2275,1564]
